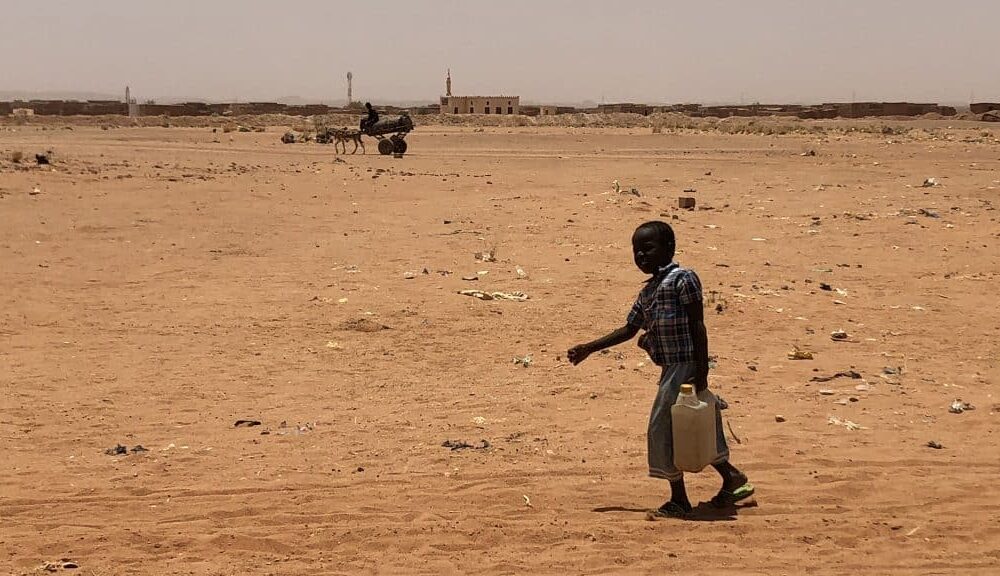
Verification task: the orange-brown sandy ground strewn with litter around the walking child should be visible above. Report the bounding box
[0,122,1000,576]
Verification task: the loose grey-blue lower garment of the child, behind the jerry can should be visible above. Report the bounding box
[646,362,729,482]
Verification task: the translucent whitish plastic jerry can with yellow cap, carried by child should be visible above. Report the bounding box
[670,384,719,472]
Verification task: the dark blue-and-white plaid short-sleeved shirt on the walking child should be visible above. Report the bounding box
[628,263,702,366]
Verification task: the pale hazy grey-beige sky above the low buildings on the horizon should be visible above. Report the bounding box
[0,0,1000,103]
